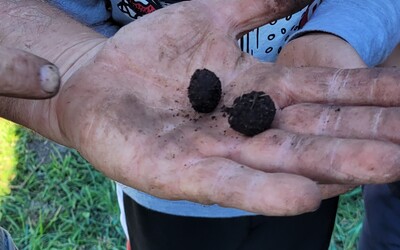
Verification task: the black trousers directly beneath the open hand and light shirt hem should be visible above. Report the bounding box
[124,194,338,250]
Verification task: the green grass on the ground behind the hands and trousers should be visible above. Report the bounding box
[0,118,364,250]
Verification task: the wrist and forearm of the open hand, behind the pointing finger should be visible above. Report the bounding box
[0,0,106,146]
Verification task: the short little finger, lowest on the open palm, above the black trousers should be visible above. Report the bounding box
[174,158,321,215]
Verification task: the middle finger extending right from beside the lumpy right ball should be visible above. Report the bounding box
[273,104,400,144]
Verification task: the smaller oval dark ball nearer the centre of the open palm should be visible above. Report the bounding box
[188,69,222,113]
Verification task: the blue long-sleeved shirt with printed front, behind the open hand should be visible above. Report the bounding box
[50,0,400,217]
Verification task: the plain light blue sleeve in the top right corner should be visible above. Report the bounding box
[291,0,400,67]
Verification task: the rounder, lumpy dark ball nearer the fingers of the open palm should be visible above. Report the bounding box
[226,91,276,136]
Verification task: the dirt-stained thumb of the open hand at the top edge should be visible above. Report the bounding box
[206,0,312,37]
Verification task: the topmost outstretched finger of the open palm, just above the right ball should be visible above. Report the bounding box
[225,63,400,108]
